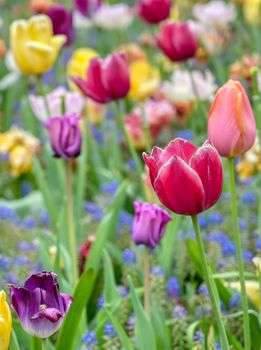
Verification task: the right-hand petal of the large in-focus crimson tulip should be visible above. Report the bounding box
[189,143,223,209]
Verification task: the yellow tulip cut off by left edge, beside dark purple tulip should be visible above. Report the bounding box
[0,290,12,350]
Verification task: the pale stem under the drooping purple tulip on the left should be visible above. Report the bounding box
[65,160,78,287]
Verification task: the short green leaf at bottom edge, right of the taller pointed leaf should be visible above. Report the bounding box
[151,303,172,350]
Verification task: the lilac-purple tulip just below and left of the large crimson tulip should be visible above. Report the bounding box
[132,201,172,248]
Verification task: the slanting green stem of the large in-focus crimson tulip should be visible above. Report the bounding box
[191,215,229,350]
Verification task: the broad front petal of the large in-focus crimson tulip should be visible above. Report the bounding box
[154,155,205,215]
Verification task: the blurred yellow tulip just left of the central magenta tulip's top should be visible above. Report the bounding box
[66,48,99,79]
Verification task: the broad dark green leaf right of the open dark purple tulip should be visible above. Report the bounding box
[56,269,95,350]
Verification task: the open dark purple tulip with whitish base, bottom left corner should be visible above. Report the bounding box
[10,271,72,338]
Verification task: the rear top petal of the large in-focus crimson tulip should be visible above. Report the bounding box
[159,138,197,167]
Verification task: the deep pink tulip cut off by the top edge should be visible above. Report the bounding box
[138,0,171,24]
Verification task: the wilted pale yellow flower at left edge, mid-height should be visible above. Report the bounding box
[0,128,39,176]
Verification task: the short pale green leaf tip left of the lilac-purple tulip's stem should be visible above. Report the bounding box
[103,249,120,304]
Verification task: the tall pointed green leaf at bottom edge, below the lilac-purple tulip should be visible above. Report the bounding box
[129,278,154,350]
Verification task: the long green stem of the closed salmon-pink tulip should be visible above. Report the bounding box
[228,158,251,350]
